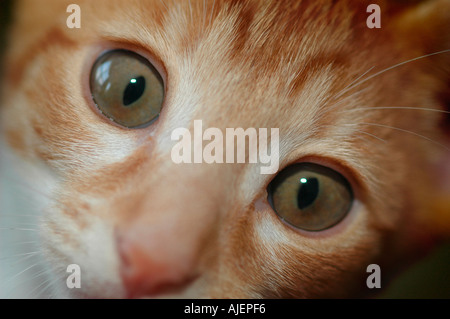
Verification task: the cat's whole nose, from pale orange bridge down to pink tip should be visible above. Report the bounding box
[115,164,224,298]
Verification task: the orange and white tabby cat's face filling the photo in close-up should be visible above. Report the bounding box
[0,0,450,298]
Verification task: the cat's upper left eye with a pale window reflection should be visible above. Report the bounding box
[90,50,164,128]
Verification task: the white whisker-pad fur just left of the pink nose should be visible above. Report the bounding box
[41,210,125,298]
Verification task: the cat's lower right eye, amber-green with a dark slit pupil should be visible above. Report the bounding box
[268,163,353,232]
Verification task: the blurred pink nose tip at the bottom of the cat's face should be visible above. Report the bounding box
[117,229,194,298]
